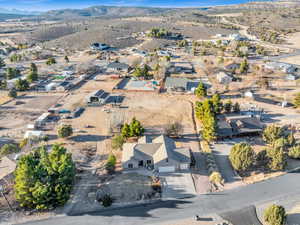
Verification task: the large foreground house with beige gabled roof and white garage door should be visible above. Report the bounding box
[122,135,191,172]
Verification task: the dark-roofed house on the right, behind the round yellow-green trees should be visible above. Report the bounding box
[217,115,264,138]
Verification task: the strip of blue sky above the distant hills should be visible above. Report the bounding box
[0,0,258,11]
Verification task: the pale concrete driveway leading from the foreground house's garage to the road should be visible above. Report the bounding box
[159,172,196,199]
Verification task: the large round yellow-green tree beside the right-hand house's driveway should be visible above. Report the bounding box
[229,143,255,171]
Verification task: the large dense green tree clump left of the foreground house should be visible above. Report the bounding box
[15,144,75,209]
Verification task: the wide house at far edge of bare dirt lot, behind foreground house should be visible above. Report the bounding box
[165,77,200,92]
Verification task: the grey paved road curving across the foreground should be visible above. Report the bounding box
[18,173,300,225]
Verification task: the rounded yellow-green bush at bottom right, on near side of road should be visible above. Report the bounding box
[264,205,286,225]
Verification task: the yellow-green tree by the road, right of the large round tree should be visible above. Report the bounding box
[267,148,287,171]
